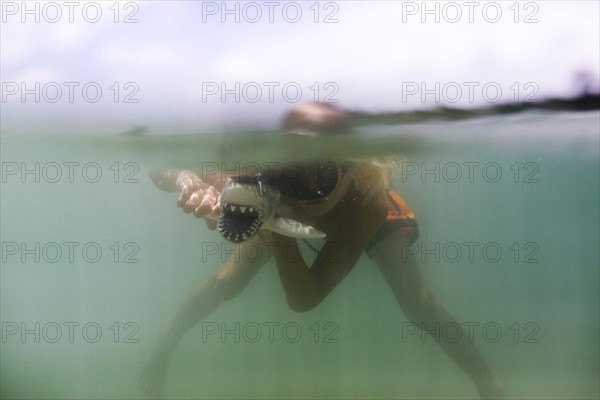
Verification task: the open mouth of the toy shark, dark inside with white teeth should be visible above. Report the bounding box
[219,203,265,243]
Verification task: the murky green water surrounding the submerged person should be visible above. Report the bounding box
[0,112,600,399]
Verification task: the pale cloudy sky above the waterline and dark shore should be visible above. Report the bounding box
[0,0,600,134]
